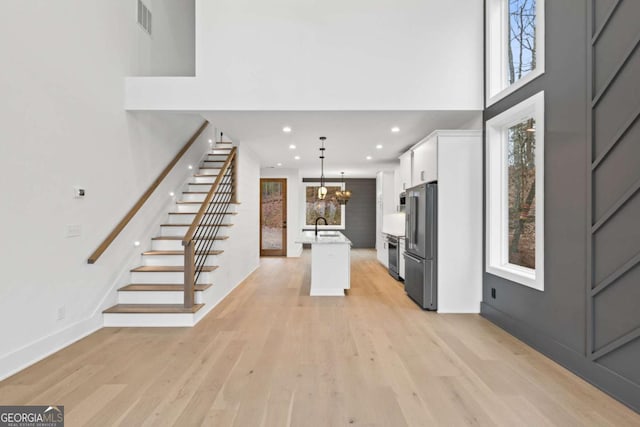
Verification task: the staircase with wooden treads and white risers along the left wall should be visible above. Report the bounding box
[103,143,237,327]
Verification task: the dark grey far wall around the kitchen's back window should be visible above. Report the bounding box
[302,178,376,248]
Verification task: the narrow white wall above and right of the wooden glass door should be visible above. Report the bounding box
[260,168,302,257]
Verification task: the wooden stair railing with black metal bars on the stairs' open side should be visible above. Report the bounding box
[182,147,237,308]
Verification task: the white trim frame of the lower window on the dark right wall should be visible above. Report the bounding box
[486,91,545,291]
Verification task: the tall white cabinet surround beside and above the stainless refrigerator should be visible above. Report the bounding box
[400,130,482,313]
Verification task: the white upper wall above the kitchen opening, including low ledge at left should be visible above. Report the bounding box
[127,0,483,110]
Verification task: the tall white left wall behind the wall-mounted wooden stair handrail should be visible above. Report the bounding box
[0,0,201,378]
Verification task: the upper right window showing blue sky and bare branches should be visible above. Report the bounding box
[486,0,544,105]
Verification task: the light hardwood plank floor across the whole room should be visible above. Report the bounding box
[0,250,640,426]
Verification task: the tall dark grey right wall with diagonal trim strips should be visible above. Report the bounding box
[482,0,640,411]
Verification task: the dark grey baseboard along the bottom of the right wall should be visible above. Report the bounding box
[480,302,640,413]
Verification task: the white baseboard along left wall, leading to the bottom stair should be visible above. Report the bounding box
[0,313,102,381]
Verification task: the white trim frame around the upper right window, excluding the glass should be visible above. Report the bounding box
[485,0,545,107]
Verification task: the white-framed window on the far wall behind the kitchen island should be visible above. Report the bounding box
[302,182,346,230]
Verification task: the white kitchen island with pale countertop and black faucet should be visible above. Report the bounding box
[296,230,351,296]
